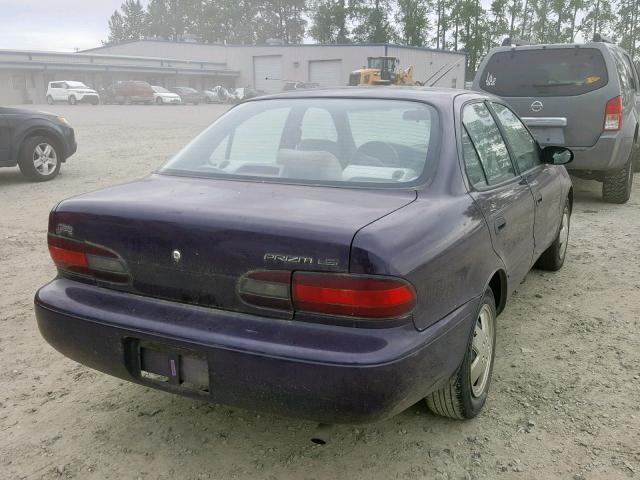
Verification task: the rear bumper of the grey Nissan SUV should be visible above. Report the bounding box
[567,132,633,173]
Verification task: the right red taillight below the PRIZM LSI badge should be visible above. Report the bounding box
[238,270,416,319]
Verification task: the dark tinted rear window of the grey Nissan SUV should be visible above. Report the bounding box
[480,48,608,97]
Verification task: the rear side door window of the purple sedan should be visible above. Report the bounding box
[462,103,516,185]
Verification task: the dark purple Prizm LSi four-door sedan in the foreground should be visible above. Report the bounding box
[35,87,573,423]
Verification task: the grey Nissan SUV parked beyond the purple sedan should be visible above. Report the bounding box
[473,37,640,203]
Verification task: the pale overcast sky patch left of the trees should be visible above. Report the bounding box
[0,0,147,51]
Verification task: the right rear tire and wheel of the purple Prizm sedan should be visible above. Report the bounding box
[426,288,497,420]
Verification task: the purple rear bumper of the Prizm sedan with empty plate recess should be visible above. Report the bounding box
[35,279,478,423]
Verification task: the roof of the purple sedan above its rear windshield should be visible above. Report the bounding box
[248,86,490,106]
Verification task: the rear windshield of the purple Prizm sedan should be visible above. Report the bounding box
[160,98,438,186]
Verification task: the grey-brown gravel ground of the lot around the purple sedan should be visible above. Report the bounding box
[0,106,640,480]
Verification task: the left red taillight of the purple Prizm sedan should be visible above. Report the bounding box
[47,233,129,283]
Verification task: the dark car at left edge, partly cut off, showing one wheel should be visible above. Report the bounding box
[0,107,77,182]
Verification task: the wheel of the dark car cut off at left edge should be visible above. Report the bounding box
[18,135,62,182]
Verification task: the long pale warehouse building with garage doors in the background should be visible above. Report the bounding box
[0,40,465,104]
